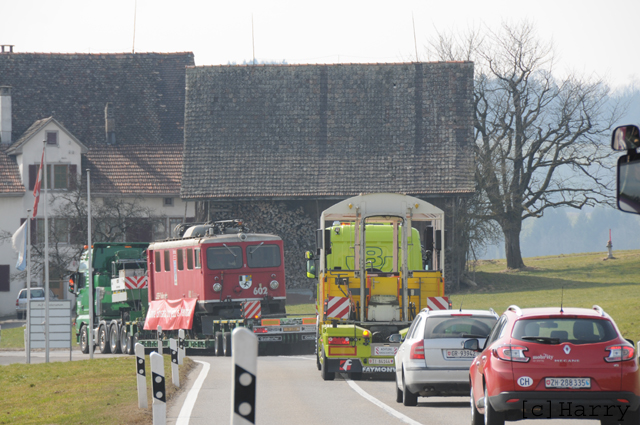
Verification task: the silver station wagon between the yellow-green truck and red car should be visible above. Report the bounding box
[391,309,498,406]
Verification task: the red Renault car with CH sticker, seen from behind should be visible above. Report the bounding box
[464,306,640,425]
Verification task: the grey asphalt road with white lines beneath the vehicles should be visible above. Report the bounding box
[167,356,599,425]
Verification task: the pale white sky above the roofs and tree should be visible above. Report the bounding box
[0,0,640,89]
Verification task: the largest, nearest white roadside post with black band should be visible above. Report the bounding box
[231,327,258,425]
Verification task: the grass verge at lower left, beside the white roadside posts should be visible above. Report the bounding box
[0,352,195,425]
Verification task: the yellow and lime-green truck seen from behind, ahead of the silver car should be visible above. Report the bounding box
[306,193,448,380]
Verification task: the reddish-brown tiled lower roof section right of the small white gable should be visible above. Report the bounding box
[82,144,182,196]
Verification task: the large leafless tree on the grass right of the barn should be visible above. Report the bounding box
[430,22,619,269]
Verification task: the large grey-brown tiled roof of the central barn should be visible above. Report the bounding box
[181,62,474,200]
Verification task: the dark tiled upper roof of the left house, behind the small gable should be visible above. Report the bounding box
[0,52,194,148]
